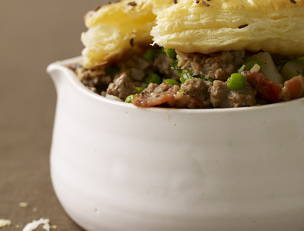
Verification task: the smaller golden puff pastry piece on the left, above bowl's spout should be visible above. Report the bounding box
[82,0,155,67]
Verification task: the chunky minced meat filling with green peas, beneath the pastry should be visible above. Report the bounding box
[71,47,304,109]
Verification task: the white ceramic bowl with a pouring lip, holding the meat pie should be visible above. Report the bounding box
[48,58,304,231]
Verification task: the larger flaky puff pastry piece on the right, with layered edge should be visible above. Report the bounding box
[152,0,304,55]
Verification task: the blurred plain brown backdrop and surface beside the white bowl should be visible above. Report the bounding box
[0,0,104,231]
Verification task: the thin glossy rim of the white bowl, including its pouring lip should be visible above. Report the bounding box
[47,56,304,114]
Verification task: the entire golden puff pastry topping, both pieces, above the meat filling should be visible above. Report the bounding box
[82,0,304,67]
